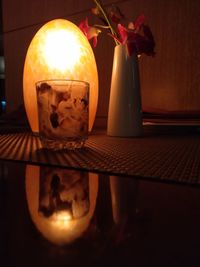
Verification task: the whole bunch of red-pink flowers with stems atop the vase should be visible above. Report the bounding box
[79,0,155,56]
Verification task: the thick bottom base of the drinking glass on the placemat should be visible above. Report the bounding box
[40,136,87,151]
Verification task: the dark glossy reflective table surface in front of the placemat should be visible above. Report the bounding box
[0,160,200,267]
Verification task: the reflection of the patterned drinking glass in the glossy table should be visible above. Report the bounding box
[38,167,90,220]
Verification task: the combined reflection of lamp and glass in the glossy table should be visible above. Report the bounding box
[26,165,98,245]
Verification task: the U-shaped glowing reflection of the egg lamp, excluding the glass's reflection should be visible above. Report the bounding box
[25,165,98,246]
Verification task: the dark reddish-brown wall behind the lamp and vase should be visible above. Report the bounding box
[2,0,200,125]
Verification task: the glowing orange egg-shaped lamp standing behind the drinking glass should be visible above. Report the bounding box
[23,19,98,133]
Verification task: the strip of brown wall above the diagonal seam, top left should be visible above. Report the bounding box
[2,0,120,32]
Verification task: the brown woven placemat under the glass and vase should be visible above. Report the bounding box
[0,133,200,185]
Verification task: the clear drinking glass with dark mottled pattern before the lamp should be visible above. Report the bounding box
[36,80,89,150]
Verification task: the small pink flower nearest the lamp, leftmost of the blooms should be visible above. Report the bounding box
[79,18,101,47]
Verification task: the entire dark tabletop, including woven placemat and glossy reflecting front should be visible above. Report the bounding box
[0,129,200,267]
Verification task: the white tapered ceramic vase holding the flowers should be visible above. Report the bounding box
[107,45,142,137]
